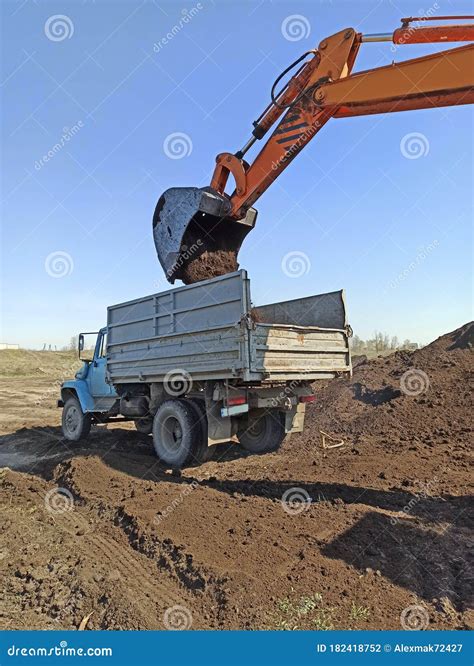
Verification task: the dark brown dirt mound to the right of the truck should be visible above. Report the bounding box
[298,323,474,482]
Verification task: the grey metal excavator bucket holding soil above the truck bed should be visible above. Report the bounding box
[153,187,257,284]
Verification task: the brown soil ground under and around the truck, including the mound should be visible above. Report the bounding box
[0,324,473,629]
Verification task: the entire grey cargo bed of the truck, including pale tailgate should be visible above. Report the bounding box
[107,270,351,385]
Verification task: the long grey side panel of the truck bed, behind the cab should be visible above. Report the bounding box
[107,271,248,384]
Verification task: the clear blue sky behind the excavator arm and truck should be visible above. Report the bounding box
[0,0,473,347]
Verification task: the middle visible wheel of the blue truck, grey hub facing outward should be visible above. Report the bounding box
[153,400,200,467]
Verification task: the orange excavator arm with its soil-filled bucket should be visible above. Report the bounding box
[153,16,474,284]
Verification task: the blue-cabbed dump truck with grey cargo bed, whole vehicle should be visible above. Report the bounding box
[58,270,351,468]
